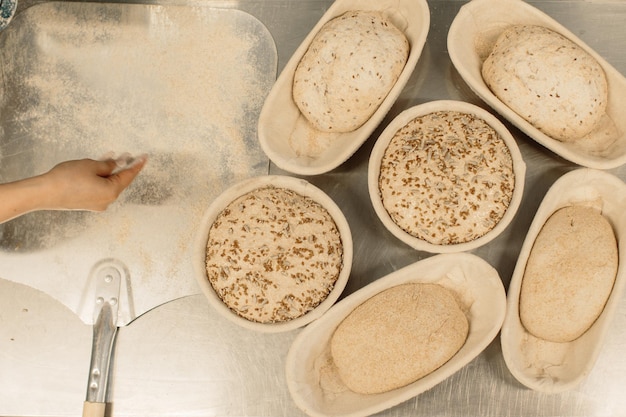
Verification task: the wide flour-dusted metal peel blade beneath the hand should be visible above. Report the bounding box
[0,2,277,322]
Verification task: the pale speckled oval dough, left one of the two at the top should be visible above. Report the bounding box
[293,11,409,133]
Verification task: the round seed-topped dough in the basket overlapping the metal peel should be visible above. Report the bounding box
[206,186,343,323]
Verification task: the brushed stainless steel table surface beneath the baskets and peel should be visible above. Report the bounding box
[0,0,626,417]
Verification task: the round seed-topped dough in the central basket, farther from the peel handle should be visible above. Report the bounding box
[378,111,515,245]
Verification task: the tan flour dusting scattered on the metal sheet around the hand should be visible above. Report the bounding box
[0,1,274,250]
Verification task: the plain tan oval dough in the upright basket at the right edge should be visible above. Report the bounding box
[519,205,618,342]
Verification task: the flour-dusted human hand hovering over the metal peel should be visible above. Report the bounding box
[41,156,146,211]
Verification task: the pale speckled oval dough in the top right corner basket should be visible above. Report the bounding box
[482,25,608,142]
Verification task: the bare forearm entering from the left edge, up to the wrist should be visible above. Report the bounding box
[0,176,47,223]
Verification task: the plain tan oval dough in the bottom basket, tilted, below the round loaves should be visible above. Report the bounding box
[330,283,469,394]
